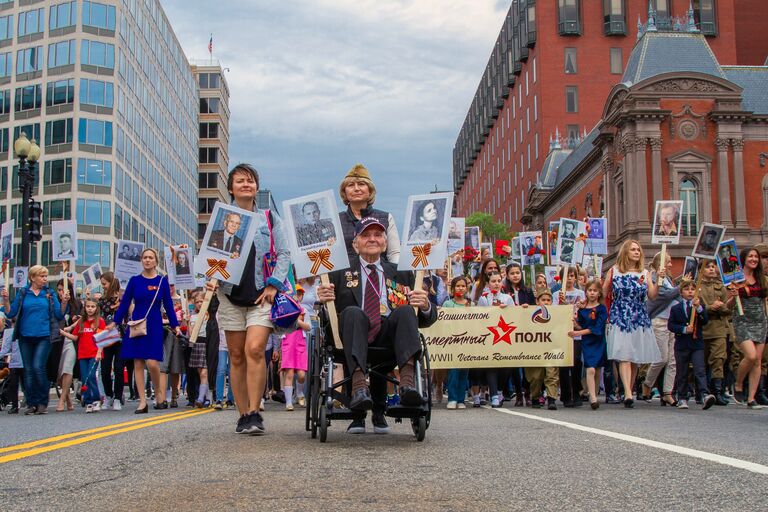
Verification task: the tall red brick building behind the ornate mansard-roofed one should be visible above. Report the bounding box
[453,0,768,233]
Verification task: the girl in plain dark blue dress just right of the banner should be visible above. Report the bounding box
[568,279,608,410]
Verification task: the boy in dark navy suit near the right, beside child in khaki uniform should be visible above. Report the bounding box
[667,279,715,410]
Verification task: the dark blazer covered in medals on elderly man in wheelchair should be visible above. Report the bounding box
[328,255,437,328]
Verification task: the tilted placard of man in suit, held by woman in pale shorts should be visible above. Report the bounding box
[194,201,264,284]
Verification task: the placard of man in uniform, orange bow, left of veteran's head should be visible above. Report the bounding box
[283,190,349,279]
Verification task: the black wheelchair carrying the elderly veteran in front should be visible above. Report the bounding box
[305,307,432,443]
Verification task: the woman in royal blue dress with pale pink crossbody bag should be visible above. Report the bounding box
[107,249,181,414]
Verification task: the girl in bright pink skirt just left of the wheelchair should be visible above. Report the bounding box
[280,286,312,411]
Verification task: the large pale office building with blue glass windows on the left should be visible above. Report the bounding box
[0,0,199,275]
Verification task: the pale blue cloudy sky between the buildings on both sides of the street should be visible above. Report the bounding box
[161,0,509,224]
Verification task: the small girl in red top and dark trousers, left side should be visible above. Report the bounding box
[59,298,107,413]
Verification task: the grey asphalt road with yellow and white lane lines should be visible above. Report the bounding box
[0,402,768,512]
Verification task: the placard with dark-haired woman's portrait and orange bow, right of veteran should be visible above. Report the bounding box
[397,192,452,270]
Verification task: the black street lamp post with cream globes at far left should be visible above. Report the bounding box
[13,132,42,267]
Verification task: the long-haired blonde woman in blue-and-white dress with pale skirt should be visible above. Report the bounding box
[603,240,666,408]
